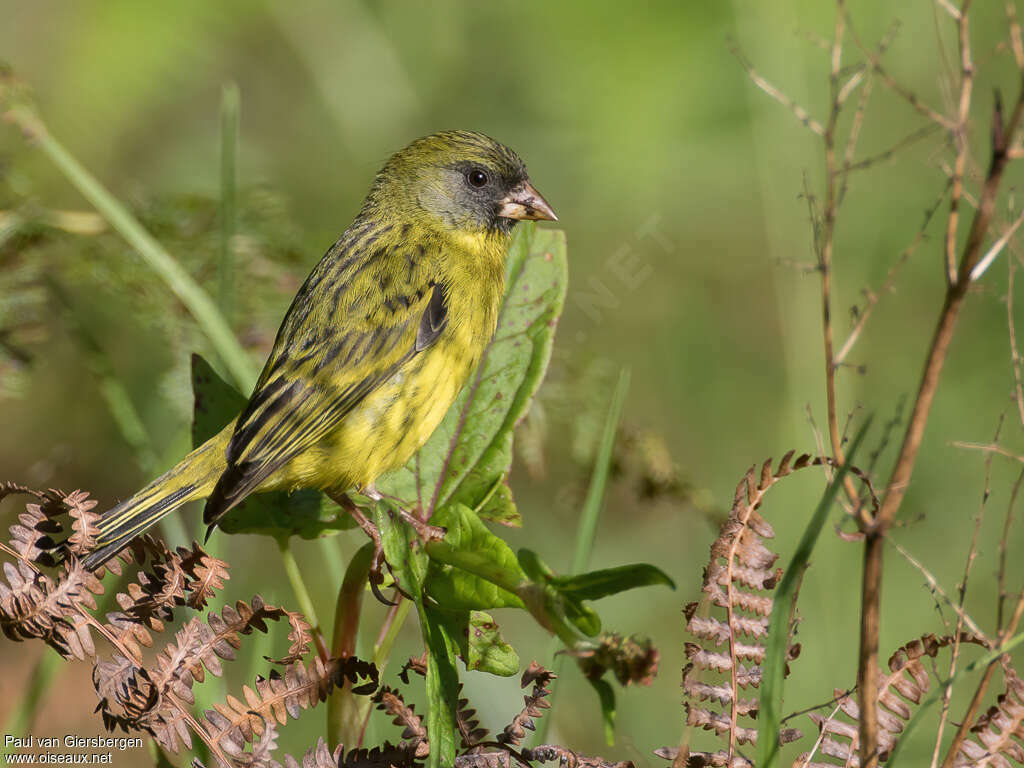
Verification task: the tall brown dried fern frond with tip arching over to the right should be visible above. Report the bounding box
[658,451,877,768]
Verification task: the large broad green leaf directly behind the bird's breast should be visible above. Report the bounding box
[377,225,567,525]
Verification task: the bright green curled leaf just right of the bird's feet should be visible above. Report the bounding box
[427,504,526,609]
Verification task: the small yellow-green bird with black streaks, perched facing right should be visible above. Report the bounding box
[85,131,556,568]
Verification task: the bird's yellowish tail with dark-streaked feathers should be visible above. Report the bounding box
[83,424,233,570]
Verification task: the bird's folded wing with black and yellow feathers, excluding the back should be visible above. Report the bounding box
[203,259,447,523]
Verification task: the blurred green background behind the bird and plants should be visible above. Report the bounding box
[0,0,1024,764]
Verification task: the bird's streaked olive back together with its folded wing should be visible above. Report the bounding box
[203,230,447,524]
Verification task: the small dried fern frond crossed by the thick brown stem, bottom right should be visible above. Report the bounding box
[798,634,983,768]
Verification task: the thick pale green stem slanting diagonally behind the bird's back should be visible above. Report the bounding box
[5,104,256,391]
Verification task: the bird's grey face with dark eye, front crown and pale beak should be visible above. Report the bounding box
[407,133,557,232]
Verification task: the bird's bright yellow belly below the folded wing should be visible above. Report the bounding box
[272,338,477,490]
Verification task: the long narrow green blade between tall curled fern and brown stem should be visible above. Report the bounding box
[757,418,871,768]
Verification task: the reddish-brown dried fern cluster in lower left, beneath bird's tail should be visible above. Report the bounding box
[0,483,377,768]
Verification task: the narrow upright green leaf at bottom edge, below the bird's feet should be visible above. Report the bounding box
[417,601,459,768]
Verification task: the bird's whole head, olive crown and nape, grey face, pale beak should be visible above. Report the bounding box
[373,131,557,233]
